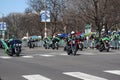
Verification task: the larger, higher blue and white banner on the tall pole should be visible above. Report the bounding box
[40,10,50,22]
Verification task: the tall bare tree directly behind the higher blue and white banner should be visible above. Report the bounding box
[28,0,64,36]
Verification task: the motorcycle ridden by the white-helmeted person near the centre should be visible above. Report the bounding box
[65,39,77,56]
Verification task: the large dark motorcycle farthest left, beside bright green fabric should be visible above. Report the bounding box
[7,40,22,56]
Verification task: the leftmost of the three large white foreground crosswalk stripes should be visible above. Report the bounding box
[22,74,51,80]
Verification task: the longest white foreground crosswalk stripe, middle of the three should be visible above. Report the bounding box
[63,72,108,80]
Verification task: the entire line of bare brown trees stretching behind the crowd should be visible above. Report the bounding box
[1,0,120,37]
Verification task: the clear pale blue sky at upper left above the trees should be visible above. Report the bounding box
[0,0,28,18]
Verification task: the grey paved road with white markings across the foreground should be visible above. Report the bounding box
[0,47,120,80]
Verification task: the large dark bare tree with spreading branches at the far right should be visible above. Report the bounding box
[78,0,119,34]
